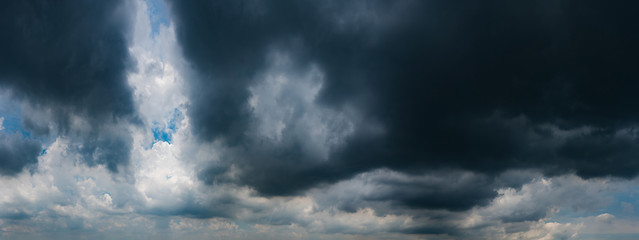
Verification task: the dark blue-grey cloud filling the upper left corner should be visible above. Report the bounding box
[0,0,134,170]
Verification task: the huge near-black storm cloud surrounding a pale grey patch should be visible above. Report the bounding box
[169,1,639,208]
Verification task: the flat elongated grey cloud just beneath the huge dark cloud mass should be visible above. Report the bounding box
[312,169,500,213]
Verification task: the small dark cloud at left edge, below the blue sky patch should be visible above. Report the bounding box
[0,133,42,176]
